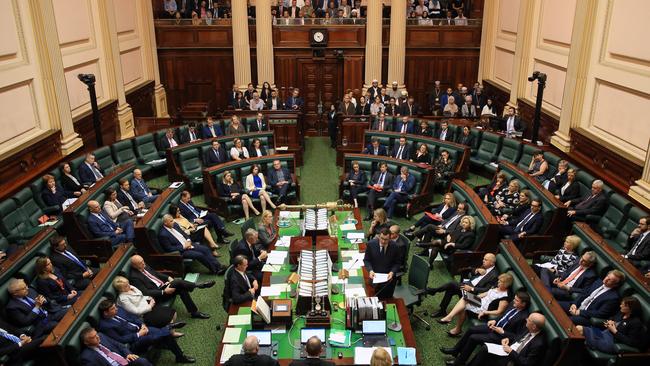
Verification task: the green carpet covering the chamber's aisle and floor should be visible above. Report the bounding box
[151,137,488,365]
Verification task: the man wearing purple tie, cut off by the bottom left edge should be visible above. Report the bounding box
[80,327,151,366]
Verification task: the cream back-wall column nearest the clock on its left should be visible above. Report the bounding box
[253,0,275,89]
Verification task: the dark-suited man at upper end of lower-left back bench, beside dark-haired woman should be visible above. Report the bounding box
[50,235,98,290]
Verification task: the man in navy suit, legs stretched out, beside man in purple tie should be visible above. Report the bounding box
[98,299,196,363]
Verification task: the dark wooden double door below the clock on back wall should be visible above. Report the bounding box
[297,58,343,136]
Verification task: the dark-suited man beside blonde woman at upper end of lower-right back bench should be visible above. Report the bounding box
[539,251,598,300]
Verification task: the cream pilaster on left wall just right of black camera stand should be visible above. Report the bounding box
[99,0,135,140]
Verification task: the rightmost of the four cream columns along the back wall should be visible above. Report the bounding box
[380,0,406,89]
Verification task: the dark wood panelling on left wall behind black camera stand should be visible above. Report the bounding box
[74,100,118,151]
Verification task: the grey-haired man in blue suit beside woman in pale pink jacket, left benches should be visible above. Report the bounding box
[86,200,135,247]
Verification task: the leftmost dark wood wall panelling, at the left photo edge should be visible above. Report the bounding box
[0,130,63,200]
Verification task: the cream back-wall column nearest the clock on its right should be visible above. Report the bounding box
[364,1,382,88]
